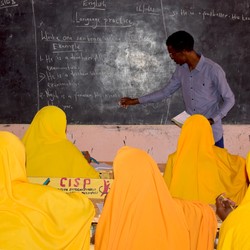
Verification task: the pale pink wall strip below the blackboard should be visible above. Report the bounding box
[0,124,250,164]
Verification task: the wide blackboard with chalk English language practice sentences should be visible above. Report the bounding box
[0,0,250,124]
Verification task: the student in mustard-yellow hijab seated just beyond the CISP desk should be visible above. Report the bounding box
[22,106,99,178]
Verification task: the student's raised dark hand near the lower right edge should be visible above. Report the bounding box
[215,194,236,221]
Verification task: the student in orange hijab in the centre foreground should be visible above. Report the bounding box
[95,146,217,250]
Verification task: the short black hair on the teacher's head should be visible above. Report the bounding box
[166,30,194,51]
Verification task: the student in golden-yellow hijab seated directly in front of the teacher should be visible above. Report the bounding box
[164,115,247,204]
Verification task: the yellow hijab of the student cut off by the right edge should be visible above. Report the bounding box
[217,153,250,250]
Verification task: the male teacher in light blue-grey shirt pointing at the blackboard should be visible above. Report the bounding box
[120,31,235,148]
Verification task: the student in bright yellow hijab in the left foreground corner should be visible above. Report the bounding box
[0,131,95,250]
